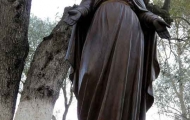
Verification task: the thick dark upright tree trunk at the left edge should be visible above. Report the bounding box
[0,0,31,120]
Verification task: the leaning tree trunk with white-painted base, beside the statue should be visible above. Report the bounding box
[15,7,71,120]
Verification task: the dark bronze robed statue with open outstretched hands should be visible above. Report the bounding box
[65,0,170,120]
